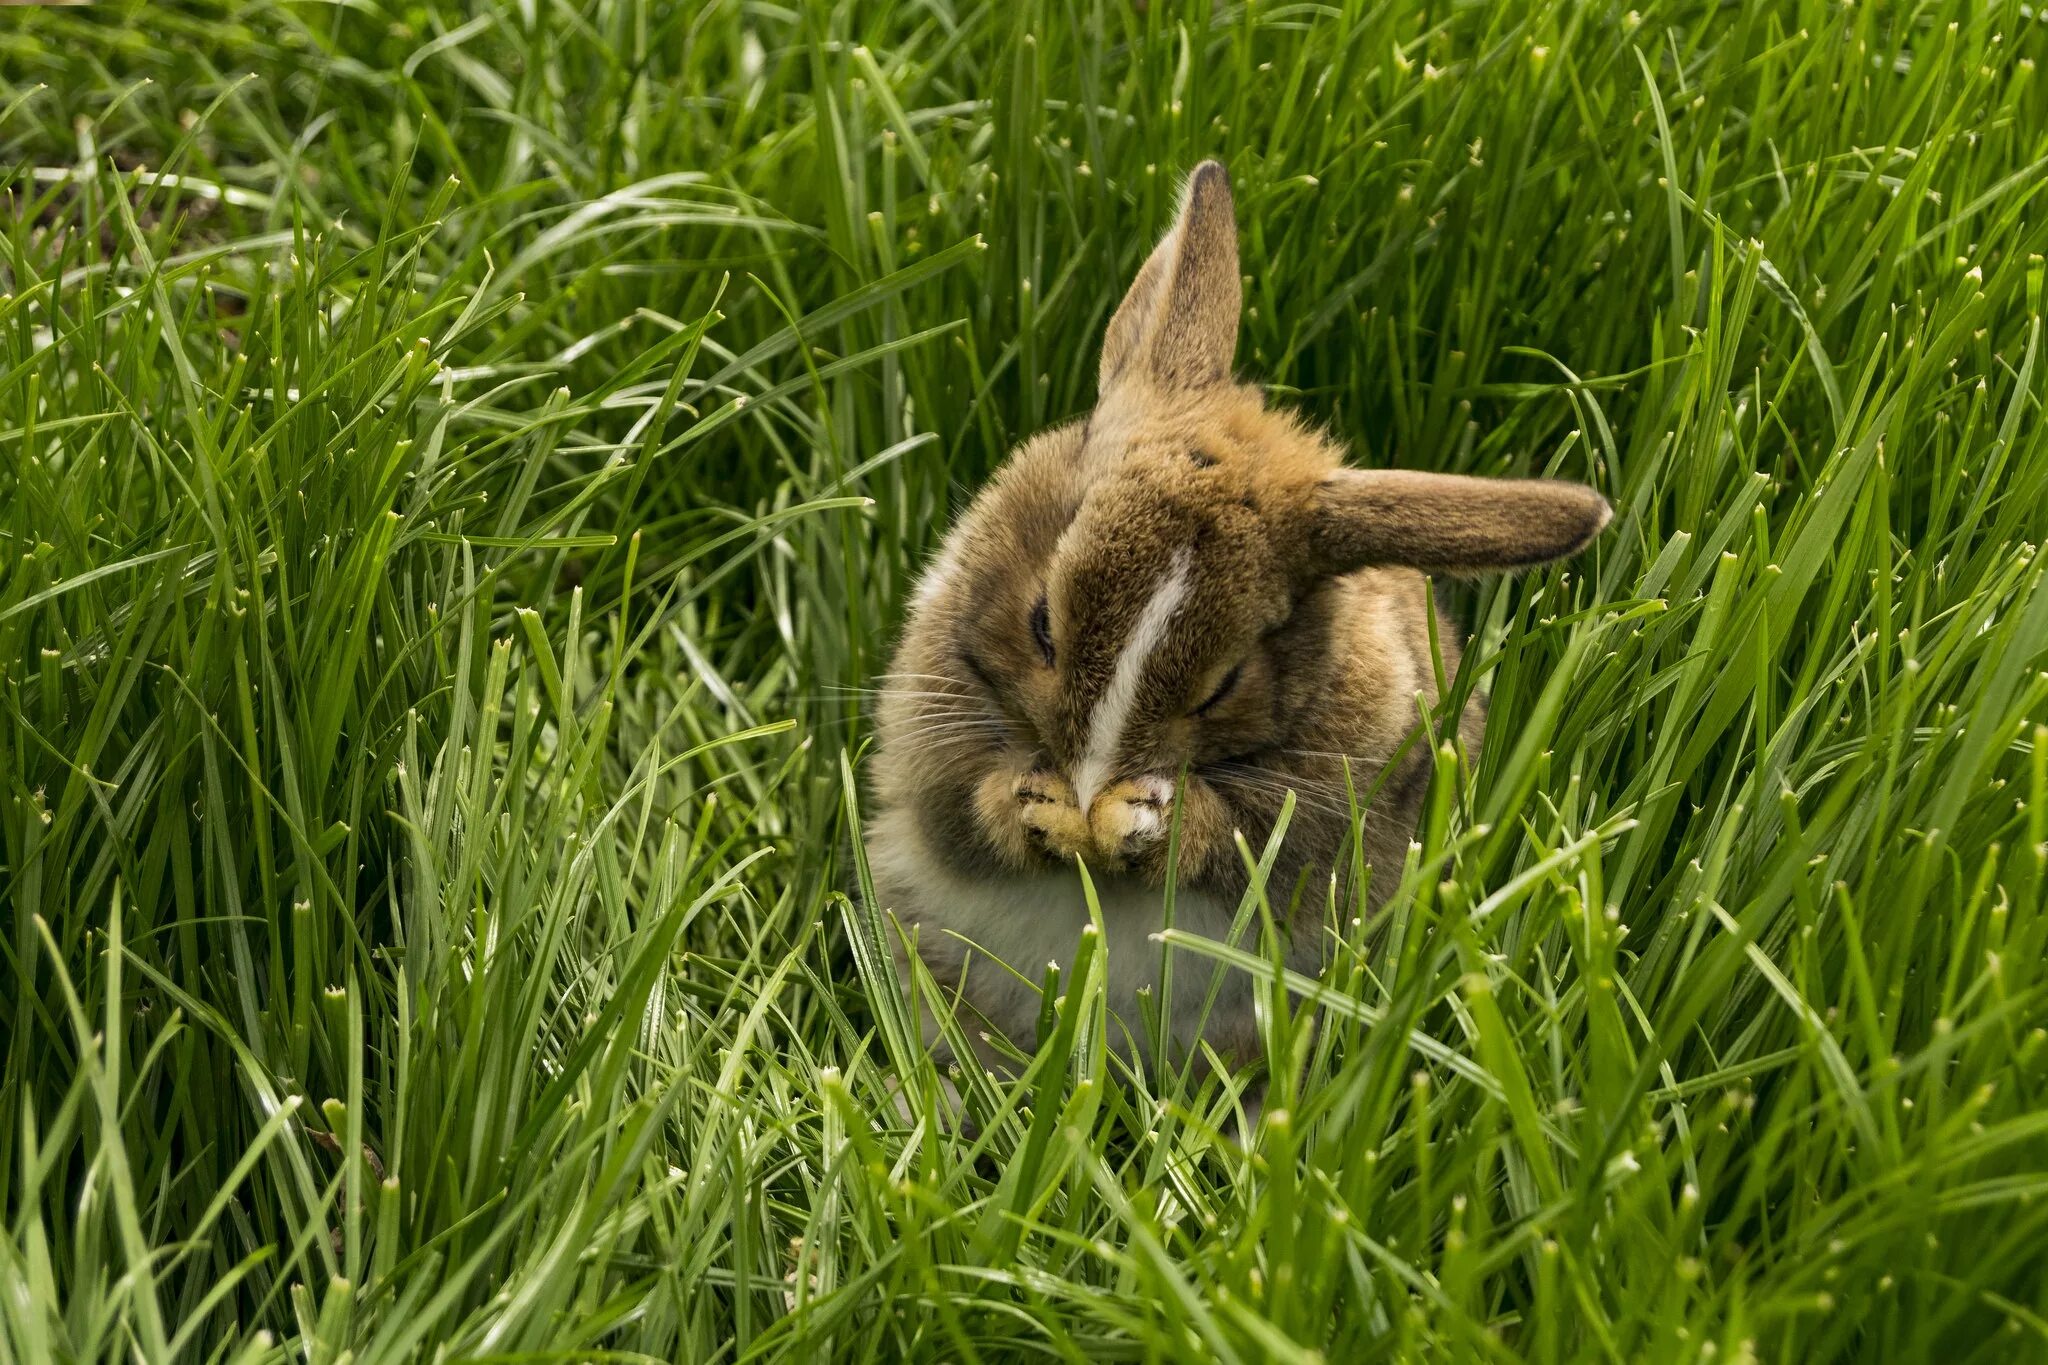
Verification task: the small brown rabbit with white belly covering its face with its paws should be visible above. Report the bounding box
[866,162,1610,1096]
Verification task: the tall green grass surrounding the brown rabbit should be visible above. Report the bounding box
[0,0,2048,1363]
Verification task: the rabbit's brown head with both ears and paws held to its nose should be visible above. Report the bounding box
[883,162,1608,888]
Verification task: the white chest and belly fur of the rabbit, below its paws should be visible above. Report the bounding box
[866,810,1255,1056]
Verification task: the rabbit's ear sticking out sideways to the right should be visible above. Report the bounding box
[1307,469,1614,575]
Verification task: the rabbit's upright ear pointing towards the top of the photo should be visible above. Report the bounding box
[1100,162,1243,393]
